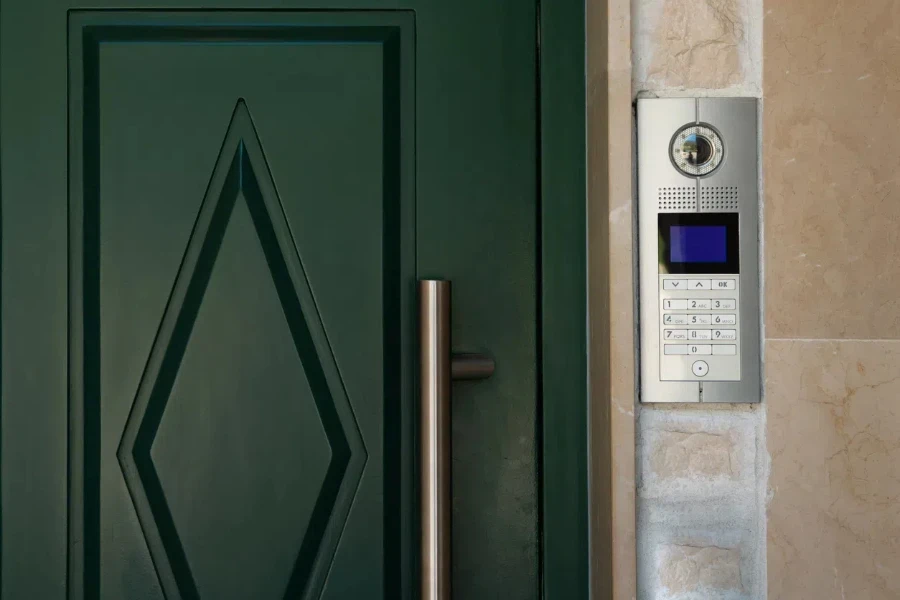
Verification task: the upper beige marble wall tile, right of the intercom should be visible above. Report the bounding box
[763,0,900,339]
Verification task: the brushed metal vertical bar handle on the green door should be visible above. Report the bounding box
[419,279,494,600]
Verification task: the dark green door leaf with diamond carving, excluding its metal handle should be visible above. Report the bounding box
[0,0,540,600]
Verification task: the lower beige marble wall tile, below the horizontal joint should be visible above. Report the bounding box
[766,341,900,600]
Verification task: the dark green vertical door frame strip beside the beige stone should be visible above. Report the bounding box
[538,0,591,600]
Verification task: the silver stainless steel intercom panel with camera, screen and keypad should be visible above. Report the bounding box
[637,98,760,402]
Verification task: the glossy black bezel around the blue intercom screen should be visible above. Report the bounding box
[658,212,740,275]
